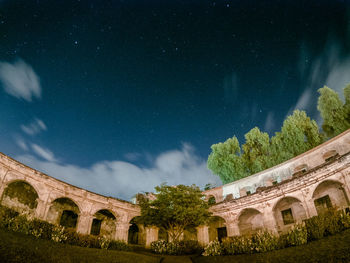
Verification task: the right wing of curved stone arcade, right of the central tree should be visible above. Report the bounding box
[198,130,350,241]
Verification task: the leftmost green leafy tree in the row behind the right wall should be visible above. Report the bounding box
[208,136,248,184]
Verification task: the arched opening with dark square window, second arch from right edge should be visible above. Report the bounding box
[273,196,306,232]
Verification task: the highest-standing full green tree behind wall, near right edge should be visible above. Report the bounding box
[317,86,350,137]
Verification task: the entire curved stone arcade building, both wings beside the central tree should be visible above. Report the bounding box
[0,130,350,246]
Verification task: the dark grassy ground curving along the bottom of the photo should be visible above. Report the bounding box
[0,229,350,263]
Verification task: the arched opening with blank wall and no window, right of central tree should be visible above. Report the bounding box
[238,208,264,235]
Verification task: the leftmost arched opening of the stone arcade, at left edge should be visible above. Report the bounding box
[1,181,39,217]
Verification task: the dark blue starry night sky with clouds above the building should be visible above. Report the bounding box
[0,0,350,199]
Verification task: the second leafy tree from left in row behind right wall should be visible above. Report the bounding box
[242,127,271,174]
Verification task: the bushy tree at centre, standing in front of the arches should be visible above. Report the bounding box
[139,184,211,241]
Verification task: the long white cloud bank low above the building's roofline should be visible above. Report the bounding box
[16,144,220,199]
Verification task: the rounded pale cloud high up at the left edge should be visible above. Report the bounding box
[0,59,41,101]
